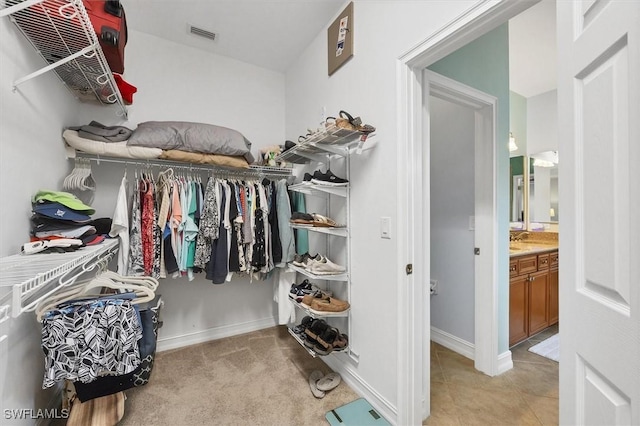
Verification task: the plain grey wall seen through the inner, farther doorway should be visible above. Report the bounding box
[429,96,475,344]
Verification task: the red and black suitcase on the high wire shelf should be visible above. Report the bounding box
[82,0,127,74]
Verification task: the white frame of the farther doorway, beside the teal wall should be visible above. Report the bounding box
[419,70,498,374]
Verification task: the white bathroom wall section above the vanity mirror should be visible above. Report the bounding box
[527,90,558,155]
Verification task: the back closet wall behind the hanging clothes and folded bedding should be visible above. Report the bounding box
[79,31,284,350]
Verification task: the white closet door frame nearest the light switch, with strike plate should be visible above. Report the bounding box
[396,0,540,425]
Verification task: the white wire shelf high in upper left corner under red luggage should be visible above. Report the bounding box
[0,0,127,118]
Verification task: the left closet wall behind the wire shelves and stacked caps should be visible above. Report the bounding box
[0,18,84,425]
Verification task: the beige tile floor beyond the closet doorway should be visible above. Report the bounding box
[423,325,558,425]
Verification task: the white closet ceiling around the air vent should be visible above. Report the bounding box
[122,0,345,72]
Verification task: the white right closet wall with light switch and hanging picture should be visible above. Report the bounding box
[286,1,475,415]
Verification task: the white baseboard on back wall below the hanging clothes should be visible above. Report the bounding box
[156,317,278,352]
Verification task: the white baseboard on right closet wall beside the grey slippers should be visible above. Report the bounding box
[322,354,398,425]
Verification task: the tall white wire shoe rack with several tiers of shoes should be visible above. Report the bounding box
[278,126,371,363]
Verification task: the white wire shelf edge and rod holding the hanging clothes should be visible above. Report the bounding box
[76,152,292,178]
